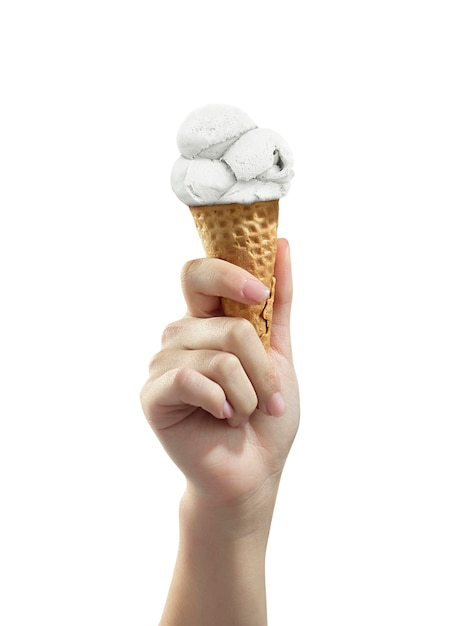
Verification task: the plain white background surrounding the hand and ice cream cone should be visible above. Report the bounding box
[0,0,470,626]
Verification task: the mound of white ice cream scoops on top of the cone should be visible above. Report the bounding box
[171,104,294,206]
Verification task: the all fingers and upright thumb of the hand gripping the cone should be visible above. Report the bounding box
[141,239,292,428]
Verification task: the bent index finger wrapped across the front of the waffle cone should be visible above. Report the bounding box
[181,259,269,317]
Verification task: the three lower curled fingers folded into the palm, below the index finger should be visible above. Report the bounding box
[144,317,285,427]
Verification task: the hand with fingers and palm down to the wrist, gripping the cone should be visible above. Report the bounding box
[141,240,299,507]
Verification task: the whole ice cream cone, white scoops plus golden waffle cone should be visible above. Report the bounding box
[171,104,294,349]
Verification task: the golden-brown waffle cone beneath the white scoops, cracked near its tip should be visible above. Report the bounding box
[189,200,279,349]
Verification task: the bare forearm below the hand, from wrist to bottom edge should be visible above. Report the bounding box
[160,492,275,626]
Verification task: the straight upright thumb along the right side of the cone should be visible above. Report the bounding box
[271,239,293,359]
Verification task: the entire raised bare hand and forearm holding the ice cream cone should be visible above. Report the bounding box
[142,240,299,626]
